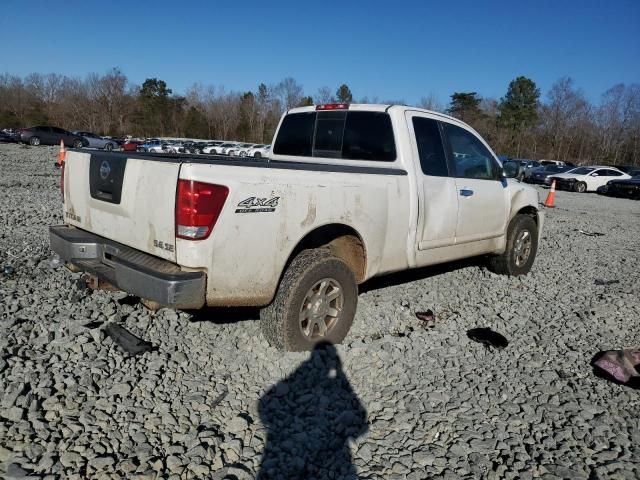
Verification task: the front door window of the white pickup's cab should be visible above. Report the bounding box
[444,123,498,180]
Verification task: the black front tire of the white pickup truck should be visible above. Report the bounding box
[488,215,538,276]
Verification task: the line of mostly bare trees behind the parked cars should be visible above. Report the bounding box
[0,68,640,165]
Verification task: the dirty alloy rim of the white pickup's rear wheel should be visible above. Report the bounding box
[298,278,344,341]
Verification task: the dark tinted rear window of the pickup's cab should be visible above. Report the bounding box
[273,110,396,162]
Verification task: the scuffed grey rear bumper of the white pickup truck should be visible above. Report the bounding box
[49,225,206,308]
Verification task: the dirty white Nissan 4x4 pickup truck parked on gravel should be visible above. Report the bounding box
[50,104,543,350]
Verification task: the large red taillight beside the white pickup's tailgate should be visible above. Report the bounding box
[176,180,229,240]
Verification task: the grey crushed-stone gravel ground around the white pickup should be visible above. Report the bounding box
[0,145,640,479]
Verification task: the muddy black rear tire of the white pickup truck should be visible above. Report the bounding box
[260,249,358,352]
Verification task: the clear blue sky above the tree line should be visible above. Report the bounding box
[0,0,640,104]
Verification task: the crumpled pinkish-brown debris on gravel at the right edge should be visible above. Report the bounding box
[591,348,640,390]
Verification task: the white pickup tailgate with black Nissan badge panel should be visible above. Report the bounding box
[64,151,180,261]
